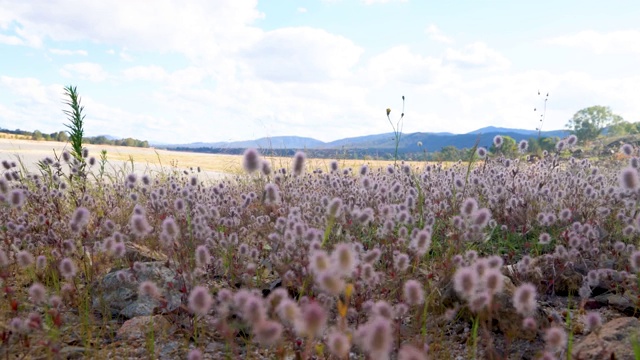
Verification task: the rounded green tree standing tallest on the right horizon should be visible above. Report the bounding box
[566,105,624,142]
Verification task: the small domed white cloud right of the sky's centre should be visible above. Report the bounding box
[444,42,510,70]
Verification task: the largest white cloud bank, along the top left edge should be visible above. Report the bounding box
[0,0,262,57]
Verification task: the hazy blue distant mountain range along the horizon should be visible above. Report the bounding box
[155,126,569,152]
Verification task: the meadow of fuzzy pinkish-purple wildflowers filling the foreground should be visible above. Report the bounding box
[0,137,640,360]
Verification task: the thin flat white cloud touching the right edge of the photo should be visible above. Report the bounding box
[546,30,640,55]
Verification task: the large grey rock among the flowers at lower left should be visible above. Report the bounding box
[92,262,184,319]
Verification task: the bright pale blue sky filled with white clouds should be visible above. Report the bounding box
[0,0,640,143]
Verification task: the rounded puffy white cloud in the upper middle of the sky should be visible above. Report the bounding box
[245,27,363,82]
